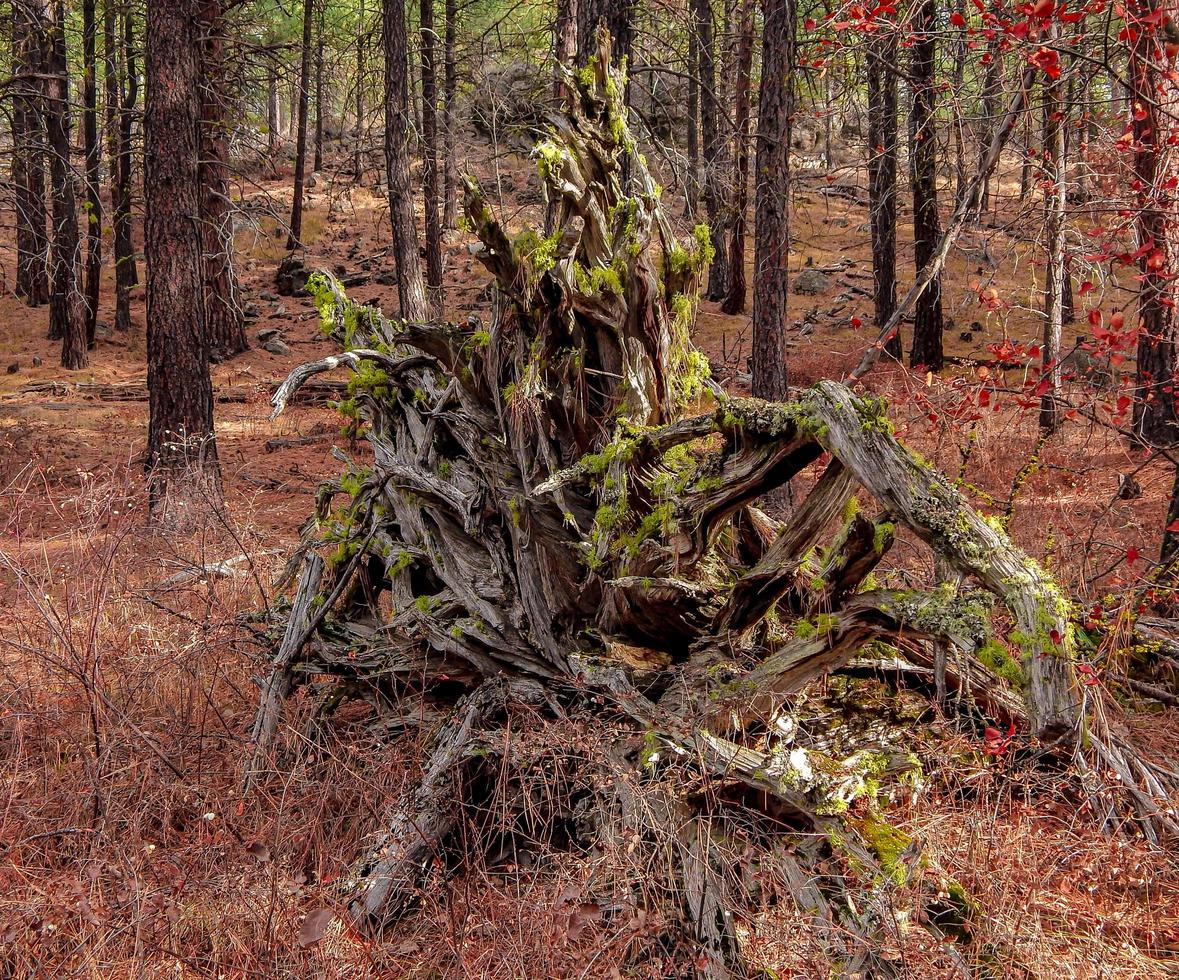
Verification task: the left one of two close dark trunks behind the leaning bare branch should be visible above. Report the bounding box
[867,28,902,361]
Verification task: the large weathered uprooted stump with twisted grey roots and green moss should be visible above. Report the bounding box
[248,39,1175,975]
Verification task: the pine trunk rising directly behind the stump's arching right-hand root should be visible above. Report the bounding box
[752,0,795,399]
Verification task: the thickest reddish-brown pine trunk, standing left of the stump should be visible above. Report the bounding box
[144,0,220,512]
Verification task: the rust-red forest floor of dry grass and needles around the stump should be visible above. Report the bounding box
[0,141,1179,980]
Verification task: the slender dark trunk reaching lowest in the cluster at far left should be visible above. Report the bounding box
[37,0,87,370]
